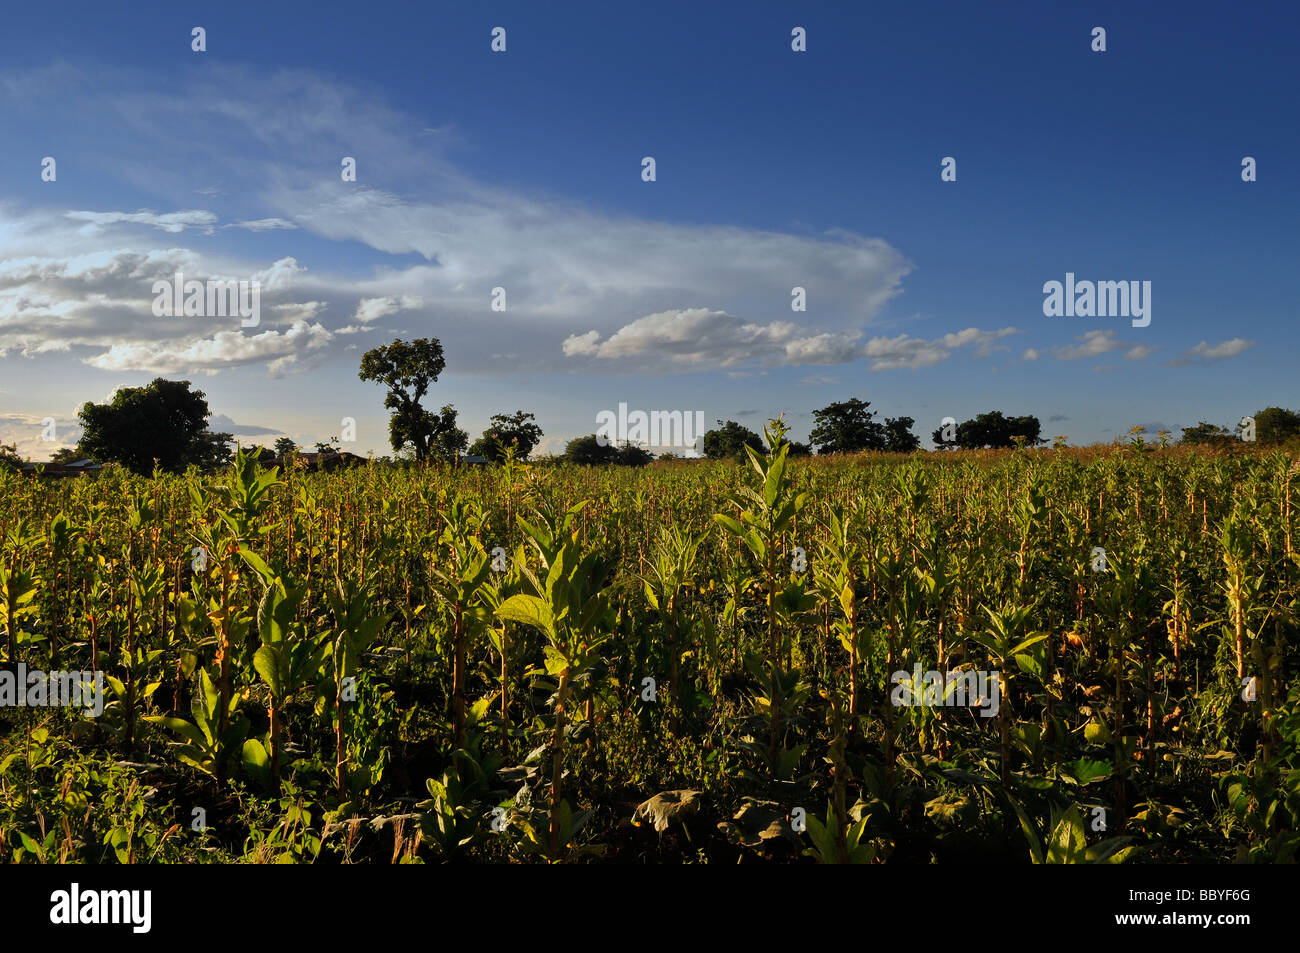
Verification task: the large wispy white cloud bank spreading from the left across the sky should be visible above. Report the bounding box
[0,64,915,373]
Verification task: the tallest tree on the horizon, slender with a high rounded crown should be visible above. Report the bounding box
[358,338,455,463]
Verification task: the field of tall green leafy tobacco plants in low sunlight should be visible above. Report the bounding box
[0,434,1300,865]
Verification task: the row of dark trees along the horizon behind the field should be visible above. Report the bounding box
[0,338,1300,473]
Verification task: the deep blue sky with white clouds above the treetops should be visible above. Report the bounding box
[0,3,1300,459]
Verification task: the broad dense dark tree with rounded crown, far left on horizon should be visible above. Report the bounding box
[77,377,234,475]
